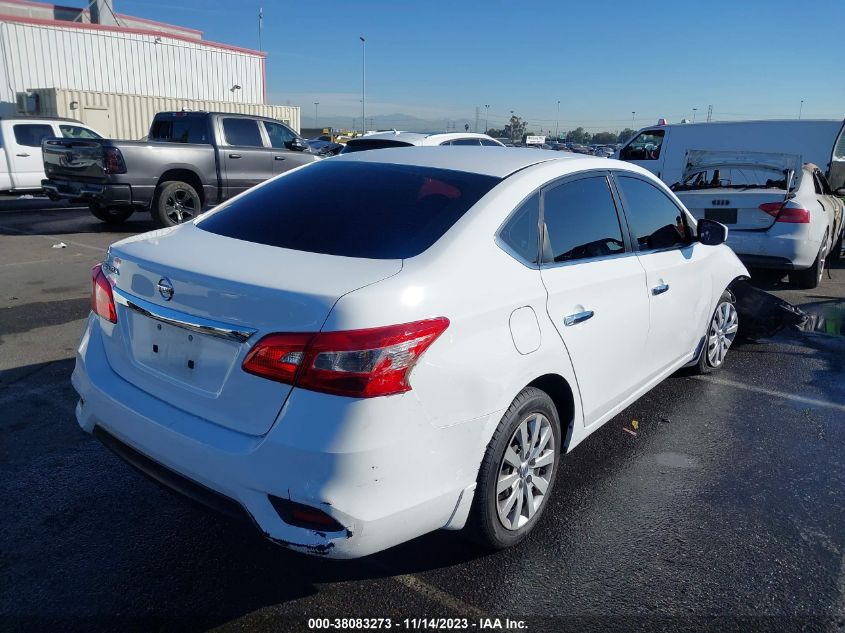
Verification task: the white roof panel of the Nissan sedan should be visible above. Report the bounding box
[329,146,600,178]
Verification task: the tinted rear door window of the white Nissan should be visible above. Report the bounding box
[543,176,625,262]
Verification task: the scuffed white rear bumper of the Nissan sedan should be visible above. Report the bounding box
[72,314,490,558]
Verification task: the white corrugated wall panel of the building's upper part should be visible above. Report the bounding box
[0,22,264,104]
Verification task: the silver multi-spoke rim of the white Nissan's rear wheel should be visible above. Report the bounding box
[496,413,556,530]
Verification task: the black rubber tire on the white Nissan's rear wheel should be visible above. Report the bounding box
[465,387,563,549]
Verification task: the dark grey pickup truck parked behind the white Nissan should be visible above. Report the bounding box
[41,112,319,226]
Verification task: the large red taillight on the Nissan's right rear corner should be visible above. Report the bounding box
[243,317,449,398]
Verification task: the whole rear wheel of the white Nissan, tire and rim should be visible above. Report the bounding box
[467,387,562,549]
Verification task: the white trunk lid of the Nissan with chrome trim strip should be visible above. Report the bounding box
[103,224,402,435]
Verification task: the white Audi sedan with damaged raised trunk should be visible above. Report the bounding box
[672,150,845,288]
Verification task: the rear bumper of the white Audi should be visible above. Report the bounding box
[728,225,821,270]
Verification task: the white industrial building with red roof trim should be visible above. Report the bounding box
[0,0,299,138]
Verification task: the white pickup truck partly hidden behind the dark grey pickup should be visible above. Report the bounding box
[0,117,103,191]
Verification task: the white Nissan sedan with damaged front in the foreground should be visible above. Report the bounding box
[73,147,747,558]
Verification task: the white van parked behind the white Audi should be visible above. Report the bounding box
[618,119,845,189]
